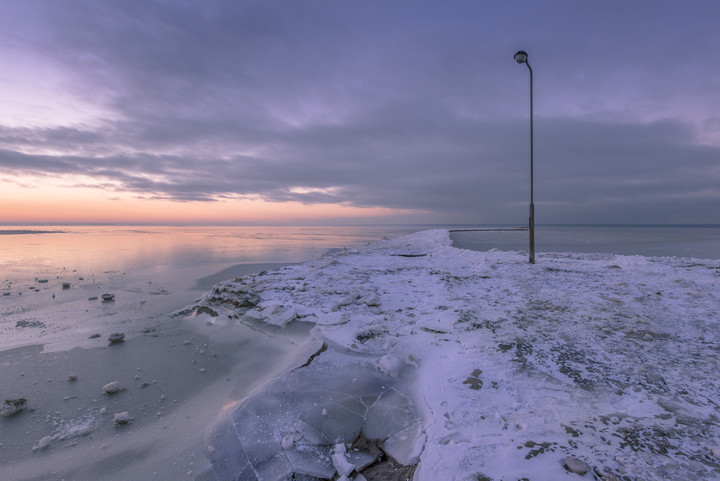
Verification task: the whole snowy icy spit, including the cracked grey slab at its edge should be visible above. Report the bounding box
[187,230,720,481]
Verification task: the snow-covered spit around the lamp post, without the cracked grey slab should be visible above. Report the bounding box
[191,230,720,480]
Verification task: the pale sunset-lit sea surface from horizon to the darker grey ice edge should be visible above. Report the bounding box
[0,226,421,350]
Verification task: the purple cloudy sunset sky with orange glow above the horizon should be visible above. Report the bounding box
[0,0,720,225]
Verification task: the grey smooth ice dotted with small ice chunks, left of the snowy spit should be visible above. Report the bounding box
[0,263,310,481]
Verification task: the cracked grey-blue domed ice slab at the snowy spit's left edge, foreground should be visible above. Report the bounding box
[205,348,423,480]
